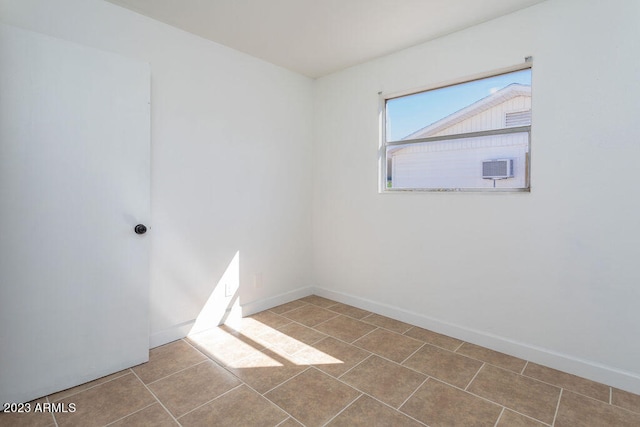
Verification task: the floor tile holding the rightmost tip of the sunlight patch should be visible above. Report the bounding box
[296,337,371,378]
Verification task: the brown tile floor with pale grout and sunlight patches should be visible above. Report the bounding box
[0,296,640,427]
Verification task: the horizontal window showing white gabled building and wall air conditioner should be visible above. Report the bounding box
[381,62,531,192]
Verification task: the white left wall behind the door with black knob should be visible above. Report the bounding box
[0,0,313,345]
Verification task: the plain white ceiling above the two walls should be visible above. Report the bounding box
[107,0,544,78]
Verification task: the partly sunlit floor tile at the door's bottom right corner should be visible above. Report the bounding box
[132,340,207,384]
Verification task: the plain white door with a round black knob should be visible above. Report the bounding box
[0,25,150,402]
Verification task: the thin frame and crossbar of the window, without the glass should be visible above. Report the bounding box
[378,61,533,194]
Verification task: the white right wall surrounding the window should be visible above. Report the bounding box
[313,0,640,392]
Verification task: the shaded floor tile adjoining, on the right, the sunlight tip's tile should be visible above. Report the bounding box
[340,355,427,408]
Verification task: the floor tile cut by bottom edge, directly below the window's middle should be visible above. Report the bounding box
[400,379,502,427]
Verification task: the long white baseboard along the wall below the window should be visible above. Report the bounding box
[312,287,640,394]
